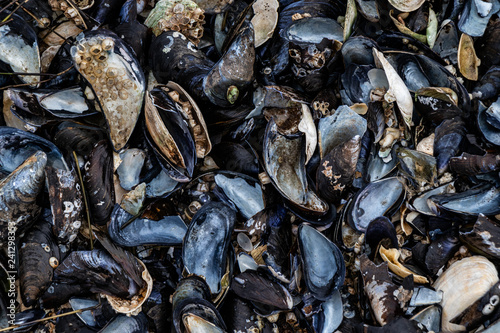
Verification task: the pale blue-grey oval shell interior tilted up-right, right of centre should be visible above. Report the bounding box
[347,177,405,232]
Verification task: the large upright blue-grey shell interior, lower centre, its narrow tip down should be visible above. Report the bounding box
[182,201,236,294]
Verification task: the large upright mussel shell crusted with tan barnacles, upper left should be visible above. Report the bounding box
[71,29,146,151]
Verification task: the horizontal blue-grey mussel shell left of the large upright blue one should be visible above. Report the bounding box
[108,204,187,247]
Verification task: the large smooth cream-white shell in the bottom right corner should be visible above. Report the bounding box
[433,256,499,331]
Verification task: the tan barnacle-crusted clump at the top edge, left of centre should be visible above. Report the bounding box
[144,0,205,45]
